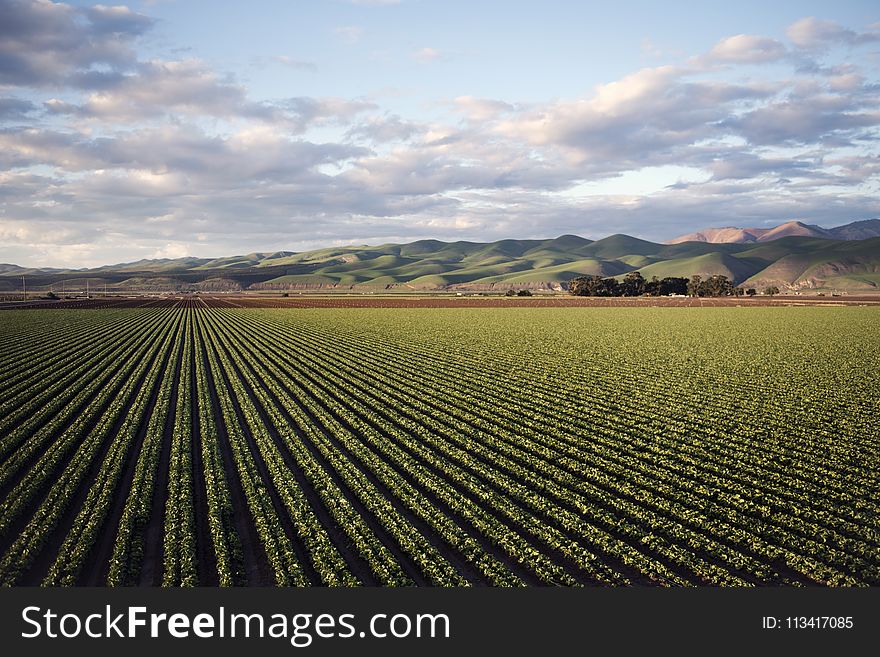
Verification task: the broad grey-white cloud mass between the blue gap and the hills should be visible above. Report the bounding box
[0,0,880,265]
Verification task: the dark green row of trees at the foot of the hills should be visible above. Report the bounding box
[568,271,779,297]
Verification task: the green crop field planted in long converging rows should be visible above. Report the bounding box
[0,301,880,586]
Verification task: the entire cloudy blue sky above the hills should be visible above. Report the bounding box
[0,0,880,267]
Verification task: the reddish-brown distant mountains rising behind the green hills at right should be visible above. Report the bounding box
[668,219,880,244]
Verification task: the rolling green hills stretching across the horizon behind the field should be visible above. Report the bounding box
[0,232,880,292]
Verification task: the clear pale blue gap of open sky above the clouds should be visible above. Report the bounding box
[127,0,880,96]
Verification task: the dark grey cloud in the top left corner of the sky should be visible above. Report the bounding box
[0,0,154,87]
